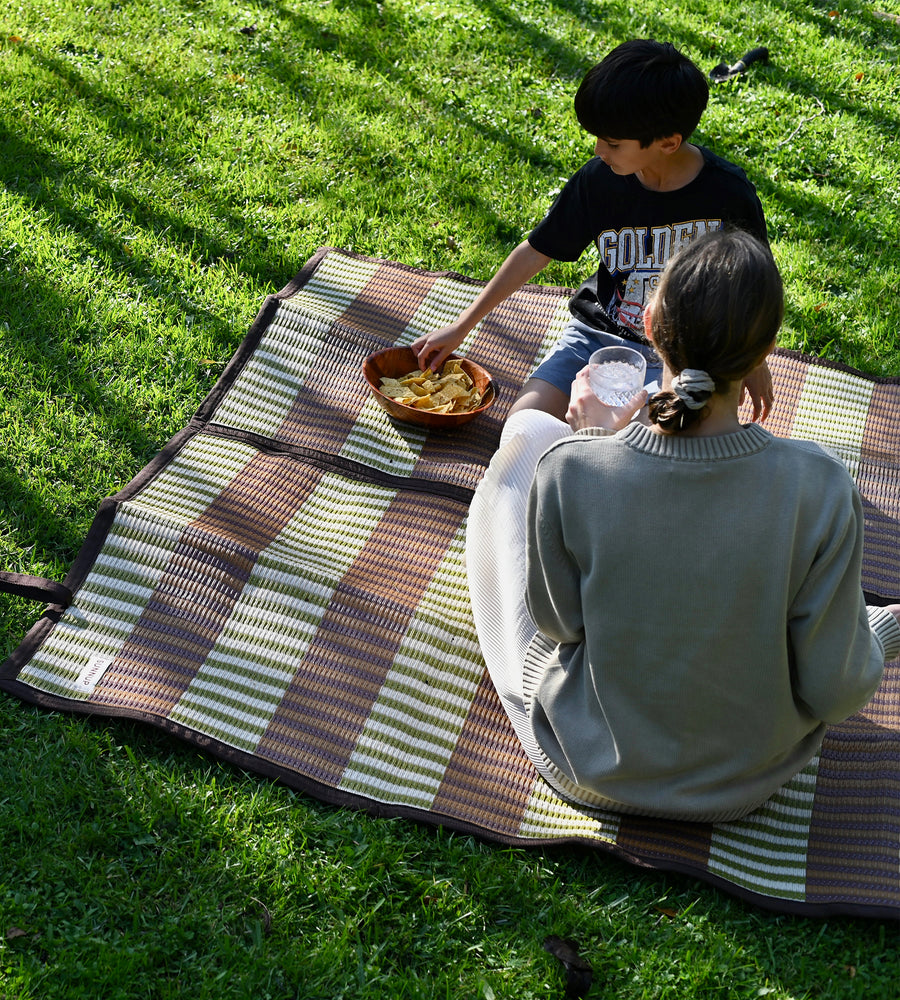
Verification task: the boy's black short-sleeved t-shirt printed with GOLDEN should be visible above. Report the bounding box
[528,146,768,341]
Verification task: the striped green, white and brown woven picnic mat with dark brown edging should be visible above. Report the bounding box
[0,248,900,917]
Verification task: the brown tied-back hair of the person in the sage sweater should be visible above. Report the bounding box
[650,229,784,434]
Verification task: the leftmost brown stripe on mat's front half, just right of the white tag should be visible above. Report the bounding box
[91,454,322,717]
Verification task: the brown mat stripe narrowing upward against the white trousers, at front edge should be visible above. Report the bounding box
[431,671,536,836]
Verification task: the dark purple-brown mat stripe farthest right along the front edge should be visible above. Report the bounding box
[806,716,900,905]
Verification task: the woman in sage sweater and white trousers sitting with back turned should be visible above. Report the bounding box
[466,232,900,822]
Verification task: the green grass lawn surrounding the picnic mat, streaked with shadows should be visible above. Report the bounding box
[0,0,900,1000]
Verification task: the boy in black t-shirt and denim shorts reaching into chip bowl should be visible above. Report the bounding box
[411,39,772,420]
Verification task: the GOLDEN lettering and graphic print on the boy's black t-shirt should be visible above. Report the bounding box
[597,219,722,334]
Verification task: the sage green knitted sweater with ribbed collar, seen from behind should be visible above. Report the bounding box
[523,423,900,821]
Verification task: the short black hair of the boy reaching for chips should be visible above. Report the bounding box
[575,38,709,147]
